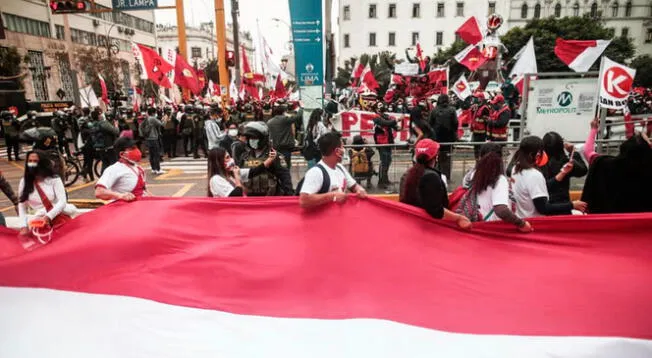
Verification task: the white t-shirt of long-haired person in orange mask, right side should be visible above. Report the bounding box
[512,168,548,218]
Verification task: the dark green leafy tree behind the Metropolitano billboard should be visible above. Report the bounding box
[501,16,635,72]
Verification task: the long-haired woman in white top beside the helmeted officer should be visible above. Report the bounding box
[208,148,275,198]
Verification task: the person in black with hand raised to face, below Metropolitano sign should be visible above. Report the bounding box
[541,132,588,210]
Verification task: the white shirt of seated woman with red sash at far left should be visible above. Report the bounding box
[18,177,67,227]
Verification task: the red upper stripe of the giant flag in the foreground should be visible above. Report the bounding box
[0,197,652,339]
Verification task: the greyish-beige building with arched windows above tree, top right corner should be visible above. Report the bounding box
[506,0,652,54]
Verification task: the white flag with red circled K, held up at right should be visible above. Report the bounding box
[598,56,636,109]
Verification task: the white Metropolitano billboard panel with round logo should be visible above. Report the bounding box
[526,78,598,141]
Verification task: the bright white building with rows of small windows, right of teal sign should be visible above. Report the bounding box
[337,0,509,66]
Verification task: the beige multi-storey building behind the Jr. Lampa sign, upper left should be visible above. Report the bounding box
[0,0,156,101]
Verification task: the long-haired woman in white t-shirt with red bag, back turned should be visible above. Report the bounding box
[457,143,532,232]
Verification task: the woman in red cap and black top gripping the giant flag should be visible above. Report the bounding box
[399,139,471,229]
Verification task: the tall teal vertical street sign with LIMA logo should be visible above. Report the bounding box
[290,0,324,87]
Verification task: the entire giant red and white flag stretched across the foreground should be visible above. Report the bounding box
[0,198,652,358]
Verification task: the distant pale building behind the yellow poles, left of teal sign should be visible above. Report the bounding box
[156,22,254,67]
